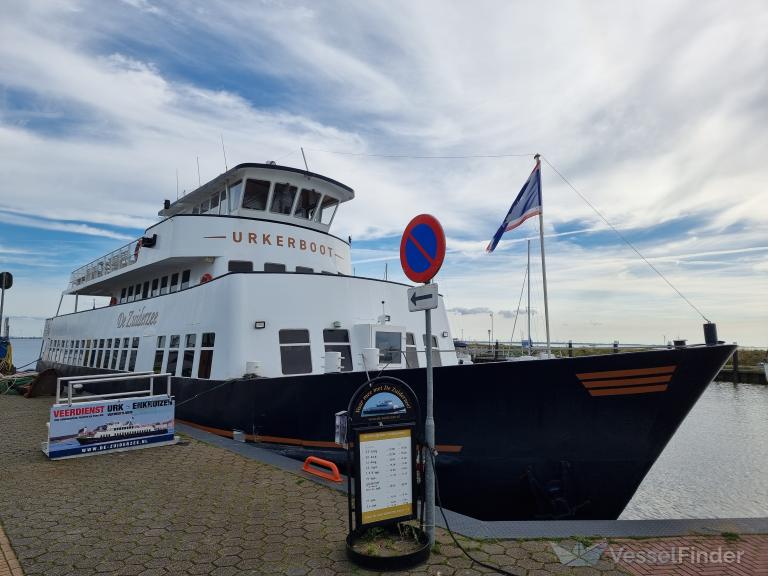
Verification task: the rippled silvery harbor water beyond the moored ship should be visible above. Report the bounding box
[11,338,768,519]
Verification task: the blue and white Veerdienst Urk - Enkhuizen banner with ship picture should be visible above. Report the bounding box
[45,395,175,458]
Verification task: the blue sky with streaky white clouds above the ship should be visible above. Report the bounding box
[0,0,768,347]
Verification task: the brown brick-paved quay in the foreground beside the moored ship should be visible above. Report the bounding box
[0,396,768,576]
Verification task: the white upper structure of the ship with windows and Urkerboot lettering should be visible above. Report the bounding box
[43,165,457,379]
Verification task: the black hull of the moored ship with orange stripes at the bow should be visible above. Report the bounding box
[41,345,734,520]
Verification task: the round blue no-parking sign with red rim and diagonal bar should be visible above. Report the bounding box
[400,214,445,283]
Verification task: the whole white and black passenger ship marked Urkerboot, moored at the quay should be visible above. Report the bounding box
[38,163,733,520]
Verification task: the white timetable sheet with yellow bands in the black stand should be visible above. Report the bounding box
[358,428,414,525]
